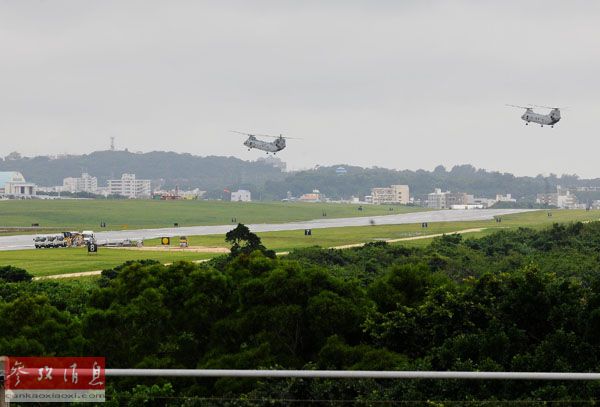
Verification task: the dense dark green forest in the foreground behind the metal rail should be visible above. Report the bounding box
[0,222,600,406]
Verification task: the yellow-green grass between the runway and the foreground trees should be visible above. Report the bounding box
[0,210,600,276]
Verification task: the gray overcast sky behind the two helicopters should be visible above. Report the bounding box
[0,0,600,177]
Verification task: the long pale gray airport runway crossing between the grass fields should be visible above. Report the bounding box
[0,209,531,250]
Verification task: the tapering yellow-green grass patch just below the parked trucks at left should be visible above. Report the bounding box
[0,247,215,276]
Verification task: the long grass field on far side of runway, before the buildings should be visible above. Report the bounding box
[0,200,425,234]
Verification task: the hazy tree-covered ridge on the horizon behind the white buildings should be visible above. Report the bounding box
[0,151,600,202]
